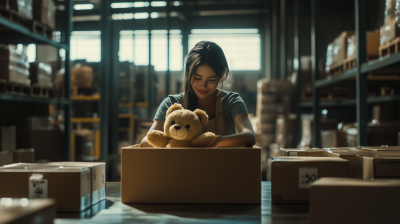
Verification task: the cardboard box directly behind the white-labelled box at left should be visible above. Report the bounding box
[46,162,106,205]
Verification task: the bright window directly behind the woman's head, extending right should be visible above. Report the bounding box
[189,29,261,71]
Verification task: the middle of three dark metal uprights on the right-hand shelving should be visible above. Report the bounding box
[311,0,322,148]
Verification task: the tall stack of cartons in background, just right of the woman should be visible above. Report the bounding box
[256,79,294,148]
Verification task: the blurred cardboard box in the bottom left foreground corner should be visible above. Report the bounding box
[0,198,56,224]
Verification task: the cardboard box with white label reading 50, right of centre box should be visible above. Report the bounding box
[271,156,349,203]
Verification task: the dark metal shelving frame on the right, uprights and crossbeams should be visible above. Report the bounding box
[295,0,400,147]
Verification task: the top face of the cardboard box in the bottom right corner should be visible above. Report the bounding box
[310,177,400,187]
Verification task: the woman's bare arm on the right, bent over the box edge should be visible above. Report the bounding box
[212,113,256,147]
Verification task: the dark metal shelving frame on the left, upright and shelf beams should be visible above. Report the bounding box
[0,1,73,161]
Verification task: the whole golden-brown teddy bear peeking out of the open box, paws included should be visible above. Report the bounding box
[147,103,216,148]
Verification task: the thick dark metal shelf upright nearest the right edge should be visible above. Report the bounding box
[355,0,368,146]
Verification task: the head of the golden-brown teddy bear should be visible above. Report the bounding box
[164,103,208,141]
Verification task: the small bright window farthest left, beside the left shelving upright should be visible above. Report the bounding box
[71,31,101,62]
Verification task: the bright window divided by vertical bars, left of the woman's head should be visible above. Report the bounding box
[119,30,182,71]
